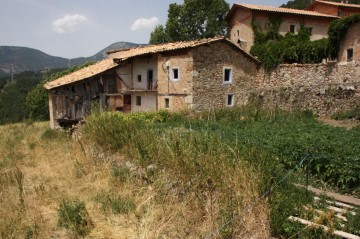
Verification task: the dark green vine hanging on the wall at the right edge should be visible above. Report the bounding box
[328,14,360,58]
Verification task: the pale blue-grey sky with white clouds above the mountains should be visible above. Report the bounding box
[0,0,287,58]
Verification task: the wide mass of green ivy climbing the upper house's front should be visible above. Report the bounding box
[250,17,328,71]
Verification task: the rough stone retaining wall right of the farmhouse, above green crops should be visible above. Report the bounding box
[249,62,360,115]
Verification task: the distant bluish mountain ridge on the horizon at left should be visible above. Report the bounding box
[0,42,140,76]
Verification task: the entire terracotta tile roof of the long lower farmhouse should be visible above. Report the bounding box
[44,37,260,90]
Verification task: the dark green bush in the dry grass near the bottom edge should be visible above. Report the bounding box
[57,200,93,236]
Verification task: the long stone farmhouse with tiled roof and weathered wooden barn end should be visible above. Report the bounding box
[44,37,260,128]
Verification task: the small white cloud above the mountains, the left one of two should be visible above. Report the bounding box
[52,14,87,34]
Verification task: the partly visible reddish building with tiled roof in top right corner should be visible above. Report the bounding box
[307,0,360,17]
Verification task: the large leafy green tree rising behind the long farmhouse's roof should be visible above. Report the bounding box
[150,0,229,44]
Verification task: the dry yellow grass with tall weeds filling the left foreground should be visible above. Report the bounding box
[0,113,269,238]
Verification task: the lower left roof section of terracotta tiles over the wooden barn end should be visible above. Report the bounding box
[44,59,118,90]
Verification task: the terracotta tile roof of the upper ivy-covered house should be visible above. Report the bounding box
[227,3,338,20]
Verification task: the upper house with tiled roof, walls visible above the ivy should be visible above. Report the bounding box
[227,4,339,52]
